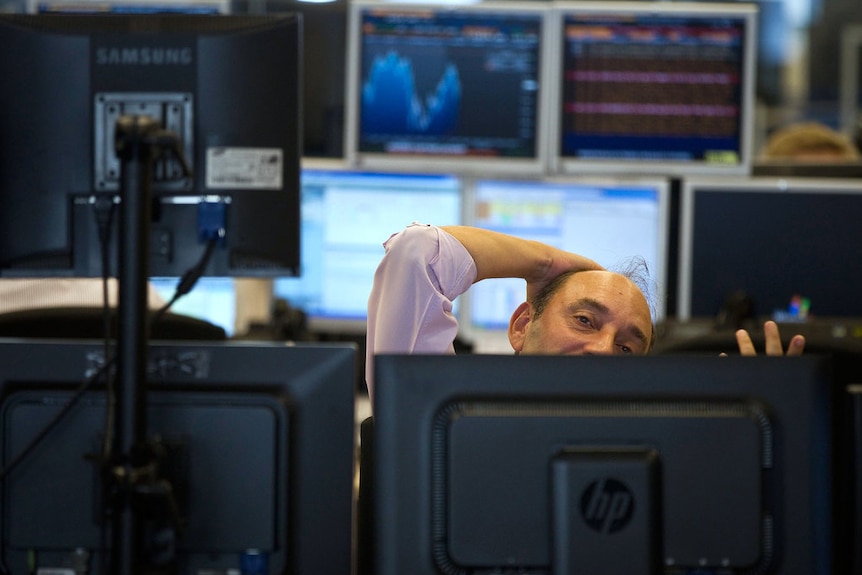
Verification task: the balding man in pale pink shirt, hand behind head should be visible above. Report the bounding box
[366,224,805,395]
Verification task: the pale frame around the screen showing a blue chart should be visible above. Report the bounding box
[344,0,554,174]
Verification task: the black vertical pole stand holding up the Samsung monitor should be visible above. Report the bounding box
[111,116,188,575]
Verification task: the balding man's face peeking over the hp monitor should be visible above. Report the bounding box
[509,271,652,355]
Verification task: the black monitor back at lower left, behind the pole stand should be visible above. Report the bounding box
[0,340,356,575]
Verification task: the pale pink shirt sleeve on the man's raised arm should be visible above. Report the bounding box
[365,224,476,397]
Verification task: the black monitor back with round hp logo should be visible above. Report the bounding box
[372,355,837,575]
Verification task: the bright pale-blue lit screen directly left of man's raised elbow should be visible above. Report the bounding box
[273,161,462,334]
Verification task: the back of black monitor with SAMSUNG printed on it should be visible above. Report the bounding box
[0,14,302,276]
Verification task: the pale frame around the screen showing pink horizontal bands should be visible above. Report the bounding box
[549,0,758,176]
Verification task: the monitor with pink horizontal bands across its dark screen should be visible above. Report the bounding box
[550,2,757,175]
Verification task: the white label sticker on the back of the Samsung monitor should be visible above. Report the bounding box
[206,148,284,190]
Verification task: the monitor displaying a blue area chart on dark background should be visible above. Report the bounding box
[345,1,549,173]
